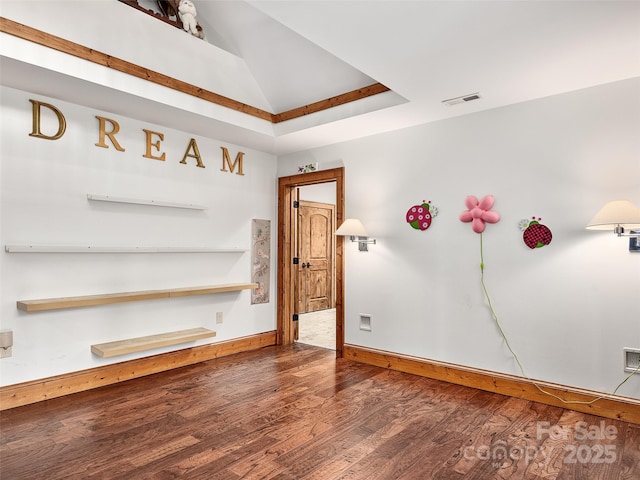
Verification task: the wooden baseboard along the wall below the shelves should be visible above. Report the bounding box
[0,331,276,410]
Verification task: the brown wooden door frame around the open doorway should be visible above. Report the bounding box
[276,167,344,358]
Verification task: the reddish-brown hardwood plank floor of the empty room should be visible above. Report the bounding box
[0,344,640,480]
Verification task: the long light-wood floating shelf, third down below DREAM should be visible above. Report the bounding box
[17,283,258,312]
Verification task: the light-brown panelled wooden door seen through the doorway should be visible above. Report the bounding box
[296,200,335,313]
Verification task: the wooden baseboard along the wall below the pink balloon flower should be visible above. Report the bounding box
[344,344,640,425]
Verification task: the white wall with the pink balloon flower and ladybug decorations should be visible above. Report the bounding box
[278,79,640,398]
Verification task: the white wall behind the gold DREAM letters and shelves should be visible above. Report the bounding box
[0,87,276,385]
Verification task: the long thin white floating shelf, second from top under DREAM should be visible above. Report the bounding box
[4,245,247,253]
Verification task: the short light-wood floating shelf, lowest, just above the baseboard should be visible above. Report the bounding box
[91,327,216,357]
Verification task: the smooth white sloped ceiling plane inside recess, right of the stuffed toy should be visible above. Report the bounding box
[195,0,376,113]
